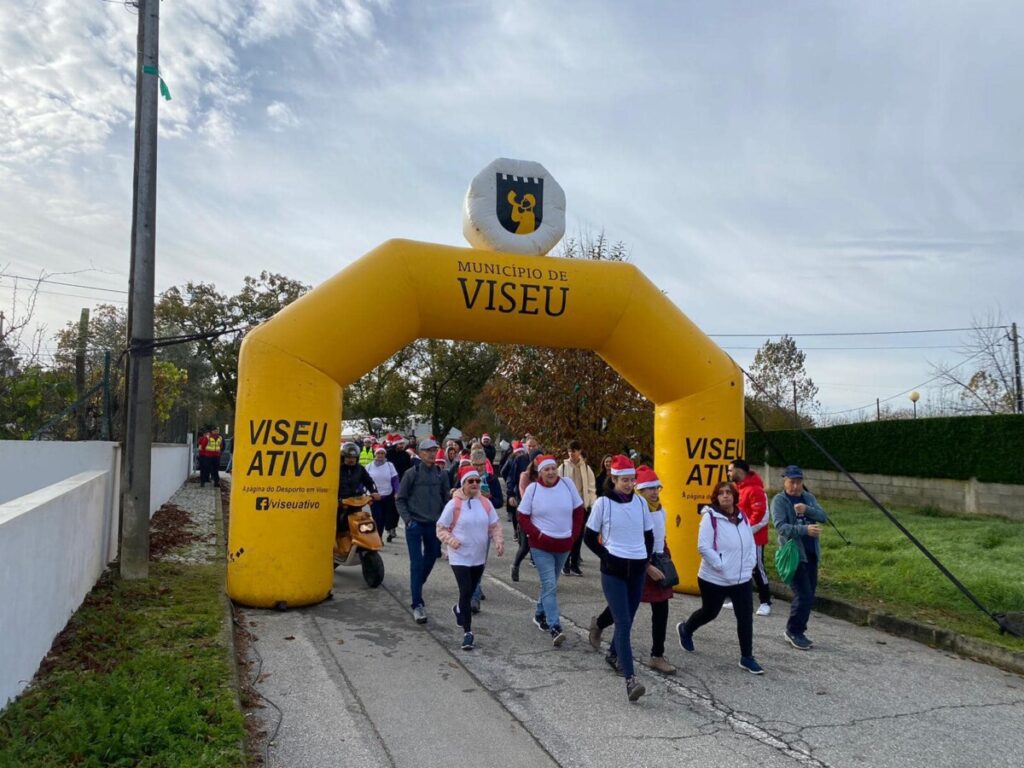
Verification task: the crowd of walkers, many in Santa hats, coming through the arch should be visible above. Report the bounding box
[342,435,827,701]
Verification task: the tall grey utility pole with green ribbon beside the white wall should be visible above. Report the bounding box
[121,0,160,579]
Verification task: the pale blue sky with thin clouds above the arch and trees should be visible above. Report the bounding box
[0,0,1024,421]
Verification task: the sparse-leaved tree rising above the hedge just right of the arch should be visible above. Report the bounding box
[746,336,820,429]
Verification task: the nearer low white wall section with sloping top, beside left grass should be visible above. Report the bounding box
[0,470,110,708]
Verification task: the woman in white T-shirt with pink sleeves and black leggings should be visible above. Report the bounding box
[437,466,505,650]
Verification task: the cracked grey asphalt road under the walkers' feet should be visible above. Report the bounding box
[237,524,1024,768]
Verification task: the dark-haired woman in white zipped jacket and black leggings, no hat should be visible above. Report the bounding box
[676,482,764,675]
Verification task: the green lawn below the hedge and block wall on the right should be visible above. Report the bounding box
[765,499,1024,651]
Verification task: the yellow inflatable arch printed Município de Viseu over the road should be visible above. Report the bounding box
[227,240,743,607]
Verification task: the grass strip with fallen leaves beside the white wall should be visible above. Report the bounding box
[0,562,246,768]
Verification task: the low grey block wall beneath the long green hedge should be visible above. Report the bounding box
[760,465,1024,520]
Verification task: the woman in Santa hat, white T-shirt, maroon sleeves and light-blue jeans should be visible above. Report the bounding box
[518,456,585,648]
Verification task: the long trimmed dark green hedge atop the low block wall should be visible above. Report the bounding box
[746,416,1024,484]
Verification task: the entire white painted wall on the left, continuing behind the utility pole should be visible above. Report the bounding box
[0,440,190,710]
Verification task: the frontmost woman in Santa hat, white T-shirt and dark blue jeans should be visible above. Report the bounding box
[584,455,654,701]
